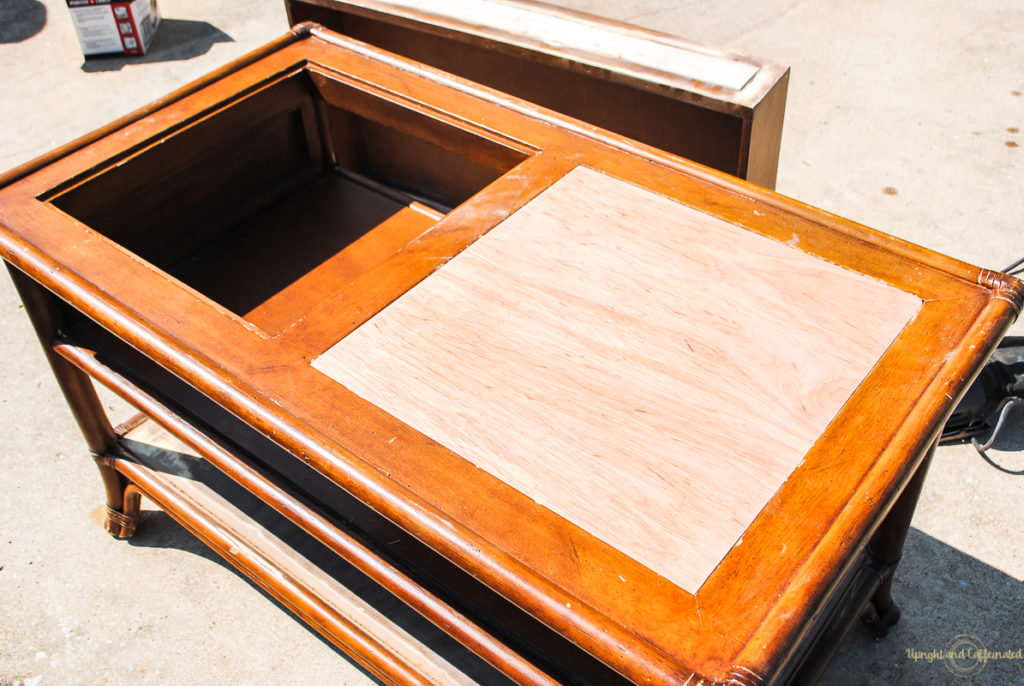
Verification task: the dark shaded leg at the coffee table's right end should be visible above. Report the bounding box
[862,444,935,637]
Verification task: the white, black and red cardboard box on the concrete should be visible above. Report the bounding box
[68,0,160,57]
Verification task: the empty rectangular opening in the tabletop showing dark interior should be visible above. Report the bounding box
[50,71,527,335]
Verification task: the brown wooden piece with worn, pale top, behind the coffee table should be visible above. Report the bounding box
[285,0,790,188]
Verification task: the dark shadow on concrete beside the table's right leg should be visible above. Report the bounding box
[821,528,1024,686]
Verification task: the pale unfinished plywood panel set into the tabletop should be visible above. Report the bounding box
[314,168,921,593]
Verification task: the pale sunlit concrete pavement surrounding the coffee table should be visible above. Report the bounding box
[0,0,1024,686]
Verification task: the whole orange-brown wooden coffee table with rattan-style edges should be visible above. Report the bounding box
[0,25,1021,685]
